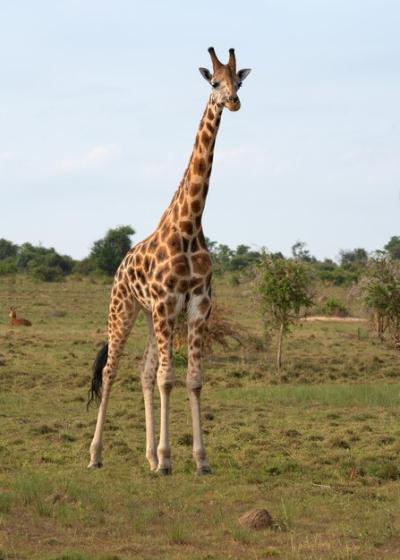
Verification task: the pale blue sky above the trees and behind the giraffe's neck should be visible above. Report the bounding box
[0,0,400,258]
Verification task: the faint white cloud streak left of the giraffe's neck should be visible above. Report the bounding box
[53,144,119,175]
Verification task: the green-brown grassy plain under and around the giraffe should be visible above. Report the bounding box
[0,278,400,560]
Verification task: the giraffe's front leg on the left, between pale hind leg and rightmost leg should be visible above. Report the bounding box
[153,318,175,475]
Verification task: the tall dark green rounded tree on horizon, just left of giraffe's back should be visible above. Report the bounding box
[89,226,135,276]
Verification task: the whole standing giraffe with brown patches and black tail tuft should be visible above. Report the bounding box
[88,47,250,475]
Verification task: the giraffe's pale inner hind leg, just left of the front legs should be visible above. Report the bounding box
[141,313,158,471]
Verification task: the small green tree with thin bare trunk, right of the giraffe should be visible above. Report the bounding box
[258,254,313,371]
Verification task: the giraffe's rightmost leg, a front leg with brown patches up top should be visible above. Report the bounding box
[186,295,211,475]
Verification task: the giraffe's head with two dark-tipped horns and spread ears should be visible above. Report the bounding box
[199,47,251,111]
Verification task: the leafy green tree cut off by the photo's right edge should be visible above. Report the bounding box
[362,256,400,345]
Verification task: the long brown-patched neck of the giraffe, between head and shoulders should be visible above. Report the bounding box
[161,95,223,237]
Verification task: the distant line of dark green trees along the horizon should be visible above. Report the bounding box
[0,225,400,286]
